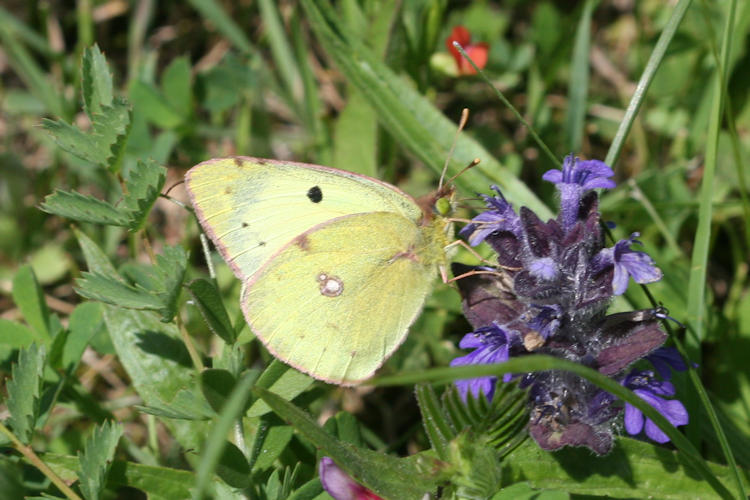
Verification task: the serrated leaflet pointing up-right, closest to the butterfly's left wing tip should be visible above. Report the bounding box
[123,160,167,231]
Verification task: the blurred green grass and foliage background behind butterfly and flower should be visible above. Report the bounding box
[0,0,750,498]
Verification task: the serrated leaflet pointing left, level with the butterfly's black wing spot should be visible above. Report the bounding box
[41,190,128,227]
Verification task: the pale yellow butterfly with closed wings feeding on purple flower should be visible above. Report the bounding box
[185,157,454,385]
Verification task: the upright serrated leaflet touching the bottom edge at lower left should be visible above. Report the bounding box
[78,422,123,500]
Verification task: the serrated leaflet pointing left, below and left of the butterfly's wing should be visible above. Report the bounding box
[76,272,163,311]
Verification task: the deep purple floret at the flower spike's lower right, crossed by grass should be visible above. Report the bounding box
[623,371,688,443]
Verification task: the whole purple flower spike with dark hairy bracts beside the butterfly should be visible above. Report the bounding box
[451,155,688,455]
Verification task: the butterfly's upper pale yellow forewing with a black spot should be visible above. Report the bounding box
[185,157,421,280]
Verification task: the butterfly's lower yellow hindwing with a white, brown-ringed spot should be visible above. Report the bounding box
[242,212,444,385]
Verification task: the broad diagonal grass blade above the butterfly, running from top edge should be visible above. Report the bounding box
[302,0,551,219]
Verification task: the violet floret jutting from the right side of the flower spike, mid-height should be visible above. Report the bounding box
[592,233,662,295]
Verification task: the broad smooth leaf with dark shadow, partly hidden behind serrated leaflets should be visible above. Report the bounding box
[75,230,208,449]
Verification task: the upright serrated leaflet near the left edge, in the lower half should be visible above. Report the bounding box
[8,344,45,444]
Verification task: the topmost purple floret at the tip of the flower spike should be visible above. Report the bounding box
[542,155,616,230]
